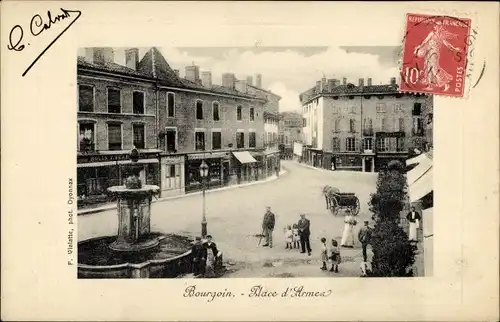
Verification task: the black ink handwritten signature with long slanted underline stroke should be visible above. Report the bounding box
[7,8,82,77]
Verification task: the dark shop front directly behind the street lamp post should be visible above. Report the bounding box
[185,152,229,193]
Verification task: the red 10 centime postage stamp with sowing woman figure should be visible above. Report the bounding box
[400,14,471,97]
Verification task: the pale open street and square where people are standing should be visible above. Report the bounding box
[78,161,377,277]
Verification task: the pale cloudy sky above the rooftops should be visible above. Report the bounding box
[78,46,400,112]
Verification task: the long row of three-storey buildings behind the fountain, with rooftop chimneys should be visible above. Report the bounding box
[77,48,267,209]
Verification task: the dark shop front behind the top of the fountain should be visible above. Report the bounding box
[77,152,160,208]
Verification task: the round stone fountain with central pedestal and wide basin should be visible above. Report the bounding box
[78,149,192,278]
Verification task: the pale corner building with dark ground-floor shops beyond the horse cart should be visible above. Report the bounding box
[300,78,432,172]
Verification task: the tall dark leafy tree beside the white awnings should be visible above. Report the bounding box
[370,161,416,277]
